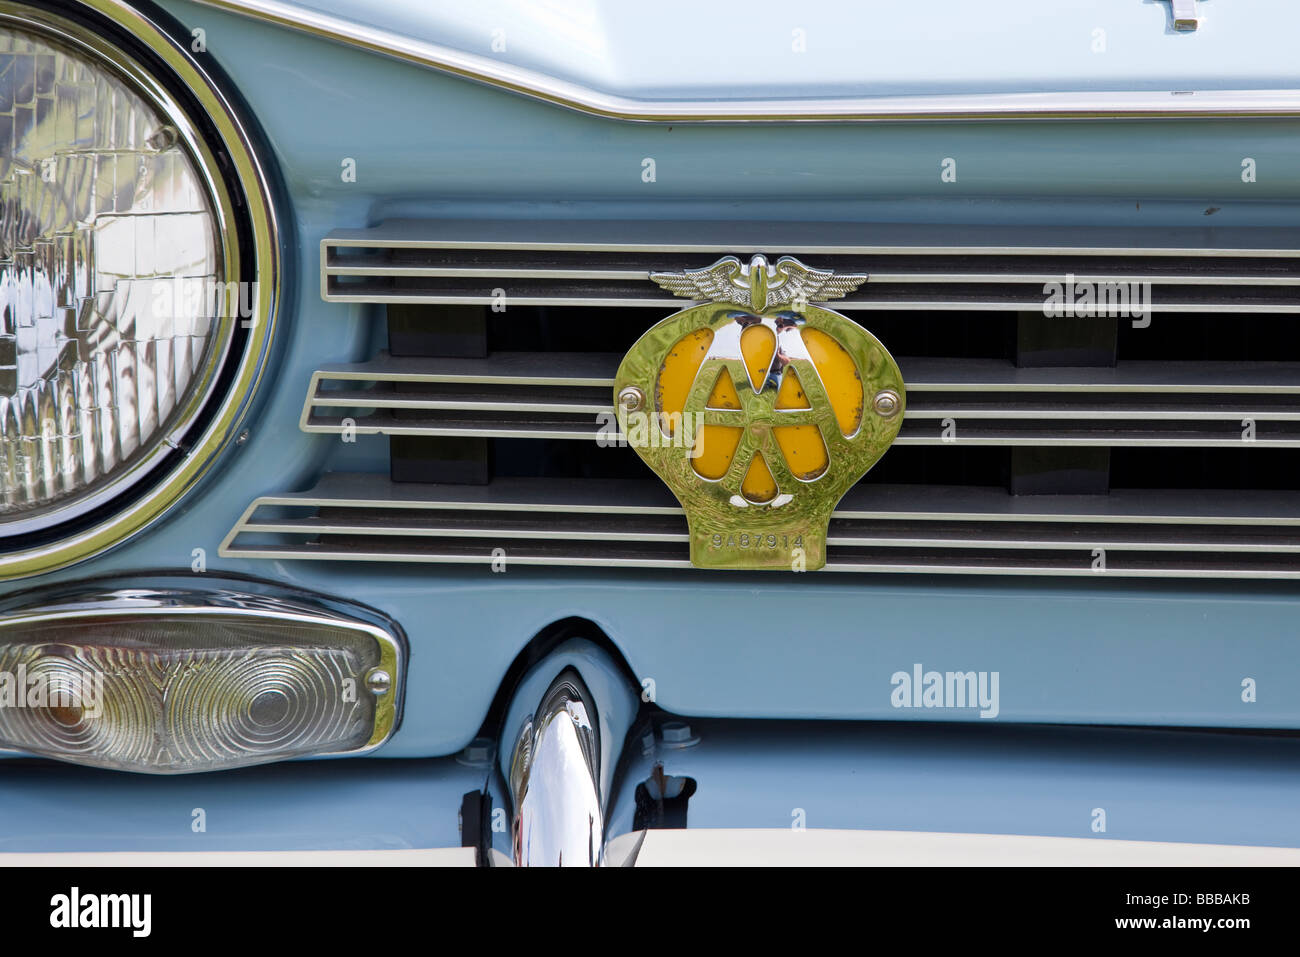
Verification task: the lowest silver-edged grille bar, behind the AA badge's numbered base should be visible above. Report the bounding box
[222,473,1300,577]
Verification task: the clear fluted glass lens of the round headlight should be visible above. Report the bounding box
[0,27,224,522]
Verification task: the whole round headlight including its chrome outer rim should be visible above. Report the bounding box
[0,0,278,577]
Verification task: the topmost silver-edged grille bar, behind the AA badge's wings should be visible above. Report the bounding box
[321,221,1300,313]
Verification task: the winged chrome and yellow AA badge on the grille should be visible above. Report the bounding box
[614,250,906,571]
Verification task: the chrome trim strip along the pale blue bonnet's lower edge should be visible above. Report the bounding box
[195,0,1300,124]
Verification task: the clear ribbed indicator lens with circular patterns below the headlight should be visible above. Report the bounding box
[0,614,395,772]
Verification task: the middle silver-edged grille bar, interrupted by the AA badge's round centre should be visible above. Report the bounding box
[302,354,1300,447]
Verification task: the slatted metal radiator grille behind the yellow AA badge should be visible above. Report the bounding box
[222,221,1300,579]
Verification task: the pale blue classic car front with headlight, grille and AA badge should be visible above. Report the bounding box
[0,0,1300,865]
